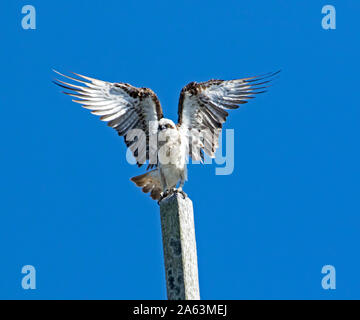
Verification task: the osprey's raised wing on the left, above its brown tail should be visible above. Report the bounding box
[54,70,163,168]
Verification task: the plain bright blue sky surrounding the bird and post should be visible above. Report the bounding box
[0,0,360,299]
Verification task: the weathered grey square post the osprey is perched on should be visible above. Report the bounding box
[160,192,200,300]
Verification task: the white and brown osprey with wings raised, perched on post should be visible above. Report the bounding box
[54,70,279,201]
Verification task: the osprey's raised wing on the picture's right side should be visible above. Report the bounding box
[178,71,279,160]
